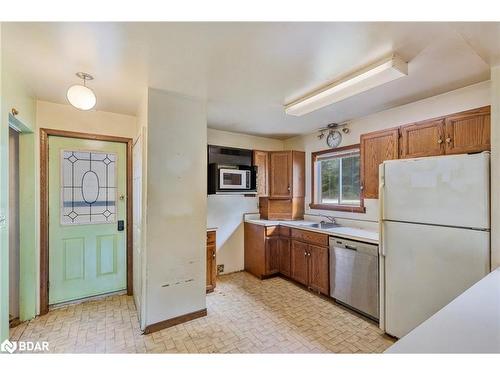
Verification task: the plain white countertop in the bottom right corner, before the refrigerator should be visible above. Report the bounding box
[385,268,500,353]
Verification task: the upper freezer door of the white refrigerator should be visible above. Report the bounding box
[381,152,490,229]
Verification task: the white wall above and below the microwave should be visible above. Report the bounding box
[207,129,283,273]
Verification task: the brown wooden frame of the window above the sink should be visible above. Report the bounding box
[309,143,366,213]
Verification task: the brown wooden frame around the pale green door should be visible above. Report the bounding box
[40,128,133,315]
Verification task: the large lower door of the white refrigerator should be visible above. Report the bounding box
[383,222,490,337]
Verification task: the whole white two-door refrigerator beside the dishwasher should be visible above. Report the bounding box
[379,152,490,337]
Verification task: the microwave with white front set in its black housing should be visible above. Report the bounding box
[208,163,257,194]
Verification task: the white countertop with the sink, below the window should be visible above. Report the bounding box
[245,219,378,244]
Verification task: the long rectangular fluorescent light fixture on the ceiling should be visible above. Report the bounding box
[285,55,408,116]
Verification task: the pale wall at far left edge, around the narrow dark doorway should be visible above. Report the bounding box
[0,44,39,327]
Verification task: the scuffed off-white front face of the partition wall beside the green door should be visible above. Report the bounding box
[144,89,207,325]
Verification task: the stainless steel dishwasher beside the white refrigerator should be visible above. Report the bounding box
[330,237,379,320]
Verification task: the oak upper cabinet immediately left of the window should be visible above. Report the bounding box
[269,151,305,199]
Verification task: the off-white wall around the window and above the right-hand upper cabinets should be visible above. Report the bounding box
[284,81,491,221]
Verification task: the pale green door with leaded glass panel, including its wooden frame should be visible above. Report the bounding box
[40,129,133,315]
